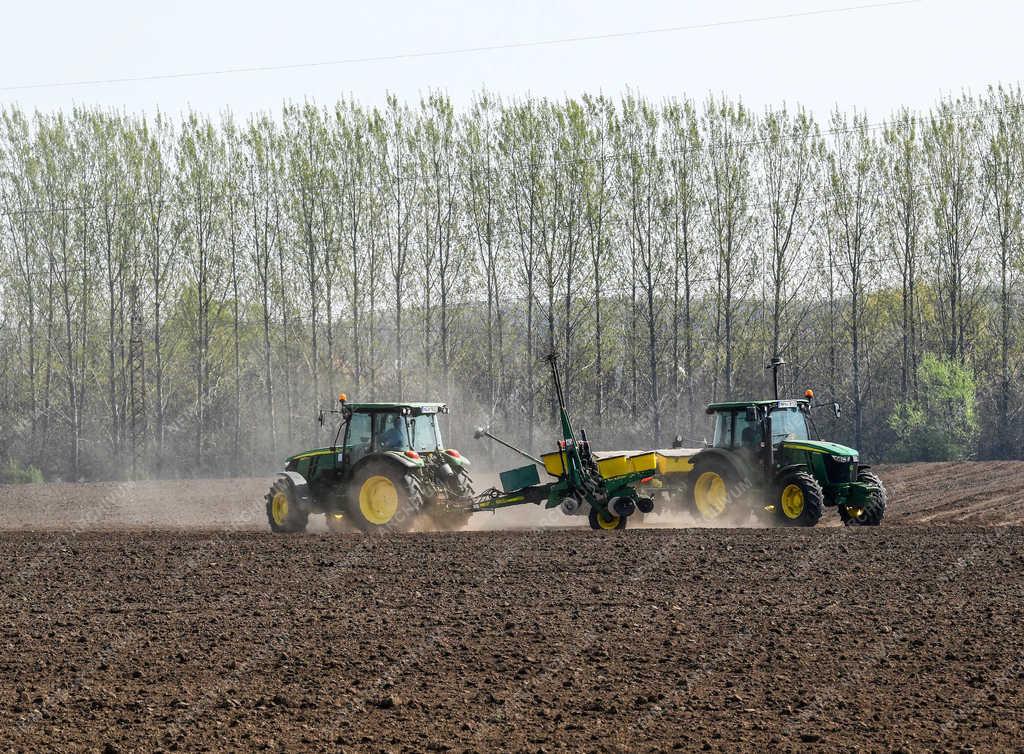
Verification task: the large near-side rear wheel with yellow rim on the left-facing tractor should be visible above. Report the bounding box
[346,460,423,532]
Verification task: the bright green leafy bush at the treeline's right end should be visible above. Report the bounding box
[889,353,980,461]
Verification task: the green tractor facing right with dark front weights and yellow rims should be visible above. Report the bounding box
[687,357,887,527]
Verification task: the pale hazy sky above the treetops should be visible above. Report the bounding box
[0,0,1024,117]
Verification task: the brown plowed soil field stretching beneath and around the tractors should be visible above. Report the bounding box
[0,463,1024,752]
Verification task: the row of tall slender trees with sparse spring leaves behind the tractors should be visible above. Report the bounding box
[0,86,1024,479]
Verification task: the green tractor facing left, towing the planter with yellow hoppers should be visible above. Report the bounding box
[266,394,473,533]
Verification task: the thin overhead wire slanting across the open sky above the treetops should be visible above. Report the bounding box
[0,0,925,91]
